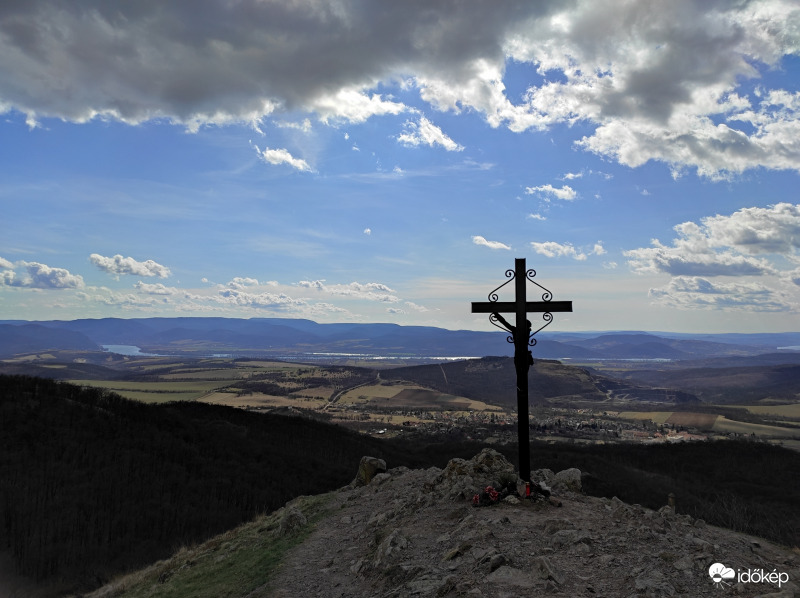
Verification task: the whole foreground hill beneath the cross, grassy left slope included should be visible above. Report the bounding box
[84,450,800,598]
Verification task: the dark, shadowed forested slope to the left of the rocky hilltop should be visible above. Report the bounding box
[0,376,400,586]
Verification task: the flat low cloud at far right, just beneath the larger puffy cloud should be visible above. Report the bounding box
[649,276,800,312]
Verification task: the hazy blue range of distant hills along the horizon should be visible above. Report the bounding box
[0,317,800,360]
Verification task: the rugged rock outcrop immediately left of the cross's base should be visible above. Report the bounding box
[432,448,517,499]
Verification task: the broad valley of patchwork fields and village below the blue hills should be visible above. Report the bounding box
[6,351,800,448]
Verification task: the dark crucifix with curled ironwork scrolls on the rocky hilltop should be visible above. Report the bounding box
[472,258,572,482]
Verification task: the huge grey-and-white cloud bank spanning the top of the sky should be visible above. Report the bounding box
[0,0,800,179]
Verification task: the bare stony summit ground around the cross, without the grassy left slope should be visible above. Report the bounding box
[270,449,800,598]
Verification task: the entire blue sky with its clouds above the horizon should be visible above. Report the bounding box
[0,0,800,333]
